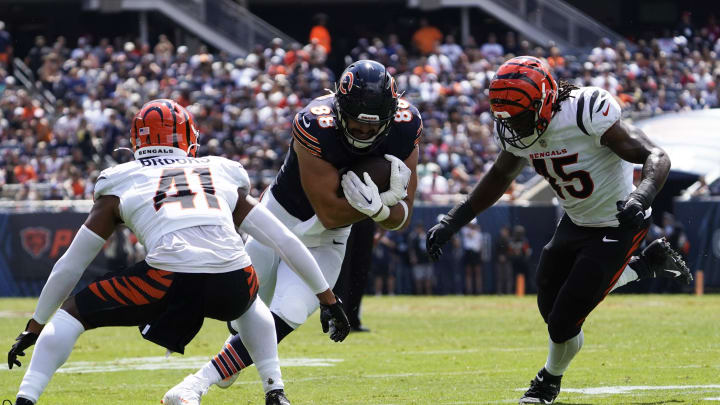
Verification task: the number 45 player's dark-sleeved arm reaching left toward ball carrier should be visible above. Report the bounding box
[426,151,525,260]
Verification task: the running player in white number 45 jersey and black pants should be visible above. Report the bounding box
[427,56,692,404]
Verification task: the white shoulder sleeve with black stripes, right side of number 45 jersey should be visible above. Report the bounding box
[577,87,622,146]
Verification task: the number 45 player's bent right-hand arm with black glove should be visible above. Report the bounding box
[600,120,670,228]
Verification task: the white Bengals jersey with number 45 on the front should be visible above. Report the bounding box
[504,87,634,227]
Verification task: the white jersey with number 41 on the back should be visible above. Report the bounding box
[94,155,250,273]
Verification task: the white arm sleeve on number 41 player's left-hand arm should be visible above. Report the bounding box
[33,225,105,325]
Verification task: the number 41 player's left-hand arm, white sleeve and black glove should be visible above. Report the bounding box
[8,196,120,368]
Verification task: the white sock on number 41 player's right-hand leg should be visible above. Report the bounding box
[233,298,285,393]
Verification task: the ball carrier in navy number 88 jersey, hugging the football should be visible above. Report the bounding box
[163,60,423,400]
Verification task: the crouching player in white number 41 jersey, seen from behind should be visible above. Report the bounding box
[8,99,349,405]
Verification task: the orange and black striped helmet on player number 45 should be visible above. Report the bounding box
[490,56,558,149]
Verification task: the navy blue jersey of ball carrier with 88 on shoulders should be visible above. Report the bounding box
[271,94,423,221]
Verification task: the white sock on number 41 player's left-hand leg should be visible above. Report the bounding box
[17,309,85,402]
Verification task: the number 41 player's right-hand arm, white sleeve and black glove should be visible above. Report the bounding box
[233,188,350,342]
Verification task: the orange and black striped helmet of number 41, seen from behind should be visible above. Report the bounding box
[130,98,198,158]
